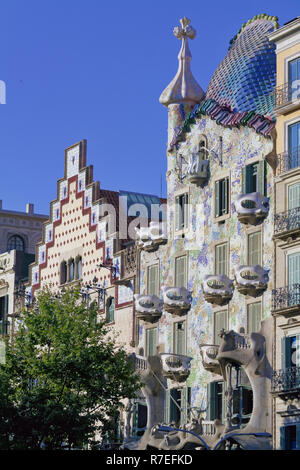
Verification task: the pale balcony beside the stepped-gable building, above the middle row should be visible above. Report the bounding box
[135,221,168,251]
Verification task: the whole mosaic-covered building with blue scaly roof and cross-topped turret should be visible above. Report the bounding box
[129,15,278,449]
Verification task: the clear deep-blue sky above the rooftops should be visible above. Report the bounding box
[0,0,300,213]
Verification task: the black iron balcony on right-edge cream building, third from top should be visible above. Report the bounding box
[274,207,300,240]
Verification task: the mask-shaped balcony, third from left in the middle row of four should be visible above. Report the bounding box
[202,274,234,305]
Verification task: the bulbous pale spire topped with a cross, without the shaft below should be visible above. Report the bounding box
[159,17,204,106]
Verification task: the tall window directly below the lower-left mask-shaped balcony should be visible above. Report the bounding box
[165,387,191,426]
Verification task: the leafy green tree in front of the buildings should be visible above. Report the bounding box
[0,290,140,449]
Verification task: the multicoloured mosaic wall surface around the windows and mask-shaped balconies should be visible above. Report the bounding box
[140,117,274,414]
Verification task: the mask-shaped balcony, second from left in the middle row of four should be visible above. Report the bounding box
[162,287,192,315]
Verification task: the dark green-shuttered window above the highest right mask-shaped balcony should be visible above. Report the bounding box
[242,160,267,196]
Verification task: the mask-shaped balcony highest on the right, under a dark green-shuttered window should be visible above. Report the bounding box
[234,192,270,225]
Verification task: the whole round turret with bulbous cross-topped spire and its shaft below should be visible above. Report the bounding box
[159,17,204,147]
